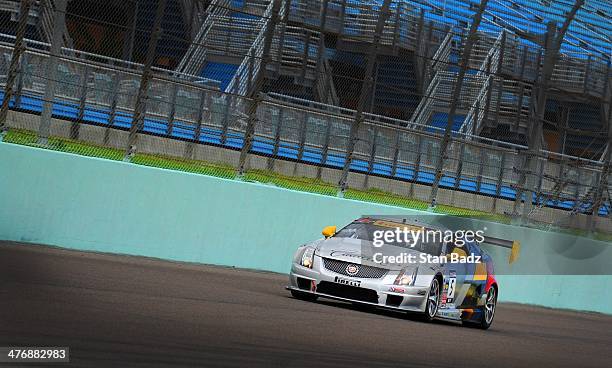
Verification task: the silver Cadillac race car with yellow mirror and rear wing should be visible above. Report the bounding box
[287,217,520,329]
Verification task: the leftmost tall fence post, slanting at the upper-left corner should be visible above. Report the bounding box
[0,0,31,137]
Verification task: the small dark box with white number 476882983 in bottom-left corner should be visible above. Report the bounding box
[0,346,70,363]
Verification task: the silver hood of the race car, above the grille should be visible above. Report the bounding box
[316,238,420,270]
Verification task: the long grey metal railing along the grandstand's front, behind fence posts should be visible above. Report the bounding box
[0,36,603,223]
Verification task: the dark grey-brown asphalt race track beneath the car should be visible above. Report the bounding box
[0,242,612,368]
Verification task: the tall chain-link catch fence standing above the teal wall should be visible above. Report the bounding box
[0,0,612,236]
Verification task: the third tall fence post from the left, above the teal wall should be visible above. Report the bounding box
[124,0,166,161]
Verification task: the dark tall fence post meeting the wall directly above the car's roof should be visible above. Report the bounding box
[429,0,489,207]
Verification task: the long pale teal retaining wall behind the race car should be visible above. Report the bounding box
[0,143,612,313]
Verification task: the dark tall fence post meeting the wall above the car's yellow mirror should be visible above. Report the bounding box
[338,0,391,194]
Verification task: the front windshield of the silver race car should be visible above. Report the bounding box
[334,221,442,256]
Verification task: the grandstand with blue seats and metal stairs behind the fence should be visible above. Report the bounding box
[0,0,612,231]
